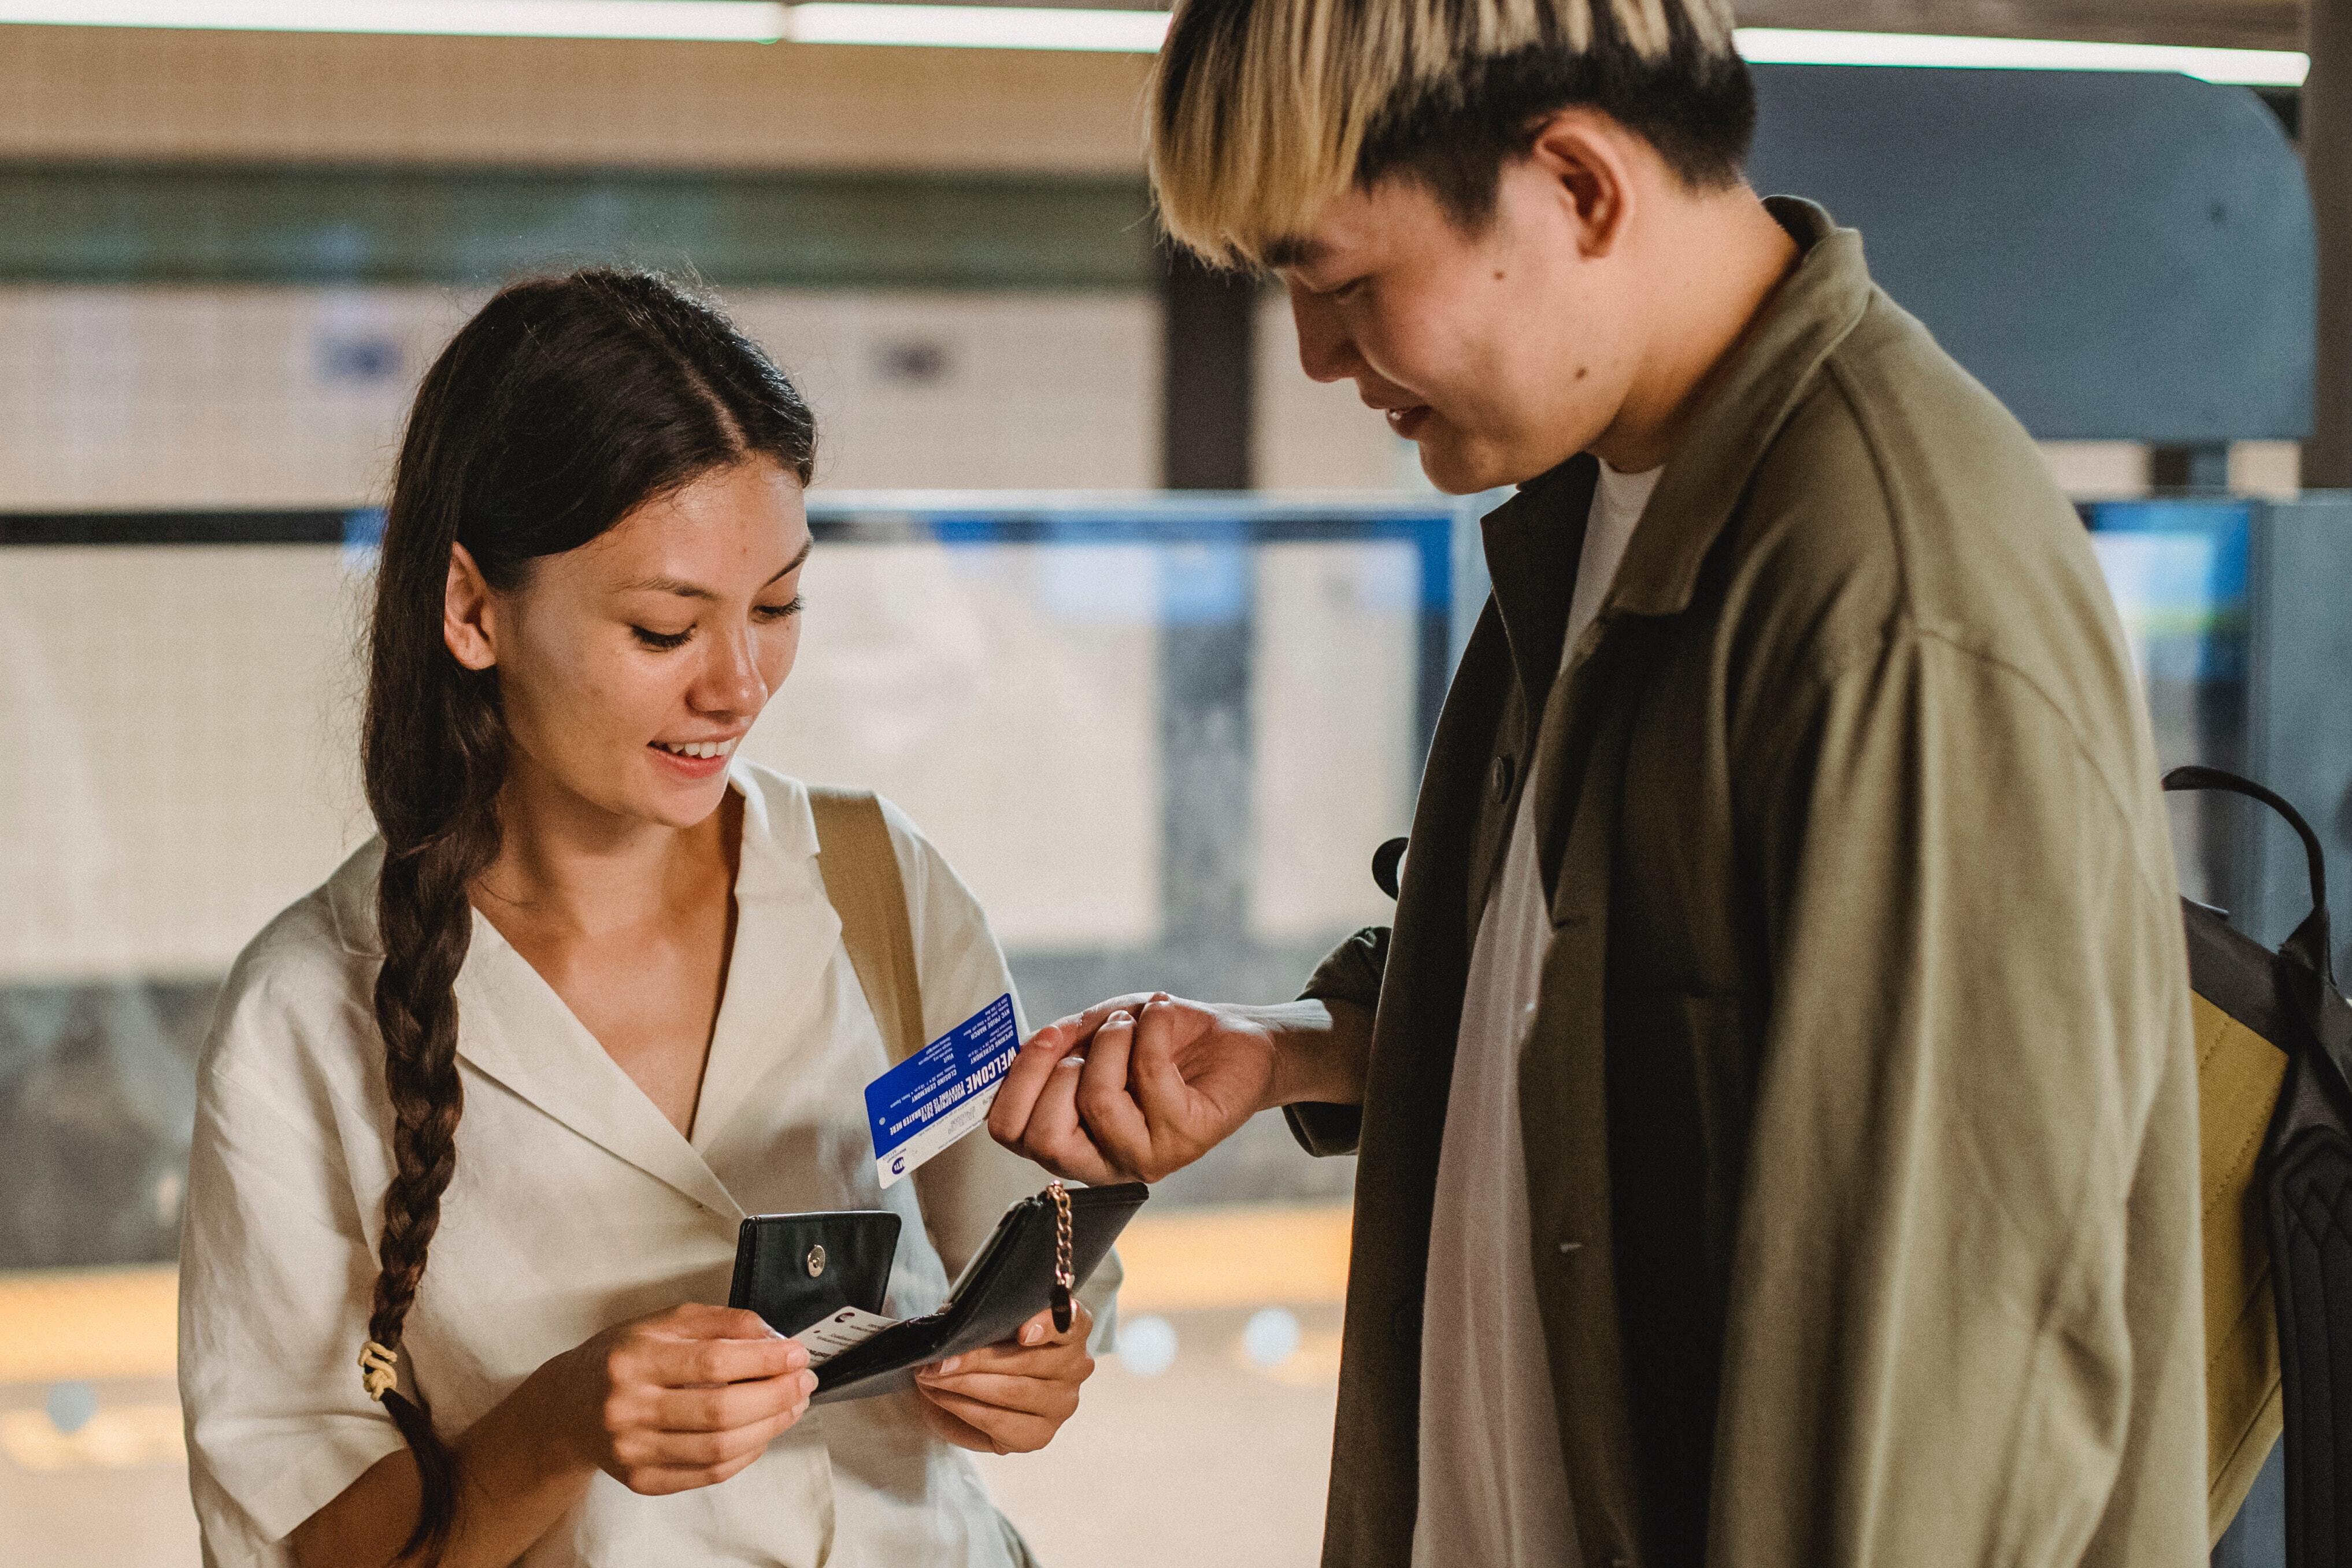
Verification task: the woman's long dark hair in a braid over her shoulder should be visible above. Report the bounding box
[362,268,816,1563]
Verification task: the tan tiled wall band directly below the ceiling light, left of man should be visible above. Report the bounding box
[0,26,1150,172]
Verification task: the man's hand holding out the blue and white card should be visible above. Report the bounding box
[988,992,1277,1187]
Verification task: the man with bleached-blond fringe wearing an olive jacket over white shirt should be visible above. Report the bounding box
[992,0,2206,1568]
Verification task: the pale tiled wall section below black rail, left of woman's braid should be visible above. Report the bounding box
[0,548,362,980]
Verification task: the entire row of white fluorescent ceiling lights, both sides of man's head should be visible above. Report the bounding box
[0,0,2310,87]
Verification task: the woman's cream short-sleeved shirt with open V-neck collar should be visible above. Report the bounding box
[179,764,1117,1568]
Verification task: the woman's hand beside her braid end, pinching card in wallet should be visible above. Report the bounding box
[546,1302,816,1497]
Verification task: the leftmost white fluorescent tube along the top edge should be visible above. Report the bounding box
[0,0,788,42]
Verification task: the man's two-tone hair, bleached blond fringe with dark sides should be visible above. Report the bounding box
[1150,0,1754,266]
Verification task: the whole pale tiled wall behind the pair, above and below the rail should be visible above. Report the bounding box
[0,287,1418,978]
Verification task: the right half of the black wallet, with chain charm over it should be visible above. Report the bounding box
[812,1183,1150,1403]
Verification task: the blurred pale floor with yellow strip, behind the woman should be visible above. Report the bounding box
[0,1206,1348,1568]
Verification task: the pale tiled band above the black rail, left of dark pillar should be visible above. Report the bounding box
[0,287,1160,510]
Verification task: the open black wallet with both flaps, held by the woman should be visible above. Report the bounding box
[757,1183,1150,1403]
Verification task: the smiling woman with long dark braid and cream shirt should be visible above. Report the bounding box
[181,270,1108,1568]
